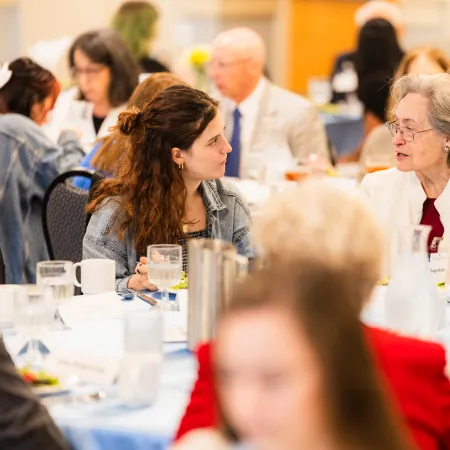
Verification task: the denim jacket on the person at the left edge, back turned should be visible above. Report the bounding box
[0,114,84,283]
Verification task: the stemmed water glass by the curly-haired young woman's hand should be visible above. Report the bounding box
[147,245,183,310]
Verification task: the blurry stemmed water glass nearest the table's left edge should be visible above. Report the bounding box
[14,284,53,370]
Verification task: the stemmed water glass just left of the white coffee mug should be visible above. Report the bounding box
[36,261,74,330]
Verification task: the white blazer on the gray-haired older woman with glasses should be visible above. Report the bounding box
[361,168,450,276]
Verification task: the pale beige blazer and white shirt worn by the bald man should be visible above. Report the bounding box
[221,77,329,181]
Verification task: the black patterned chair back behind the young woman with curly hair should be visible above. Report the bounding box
[42,169,94,262]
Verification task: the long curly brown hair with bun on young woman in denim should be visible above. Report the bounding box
[88,86,219,254]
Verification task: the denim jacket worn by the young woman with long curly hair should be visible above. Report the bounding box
[83,179,253,292]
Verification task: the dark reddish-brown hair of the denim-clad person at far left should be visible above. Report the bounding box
[0,58,61,118]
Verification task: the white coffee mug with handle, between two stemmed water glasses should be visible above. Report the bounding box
[73,259,116,294]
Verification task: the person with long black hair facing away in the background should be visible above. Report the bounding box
[339,19,403,162]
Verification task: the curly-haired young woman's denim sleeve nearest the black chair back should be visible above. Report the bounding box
[83,200,132,291]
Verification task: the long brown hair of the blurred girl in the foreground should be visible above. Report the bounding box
[218,259,411,450]
